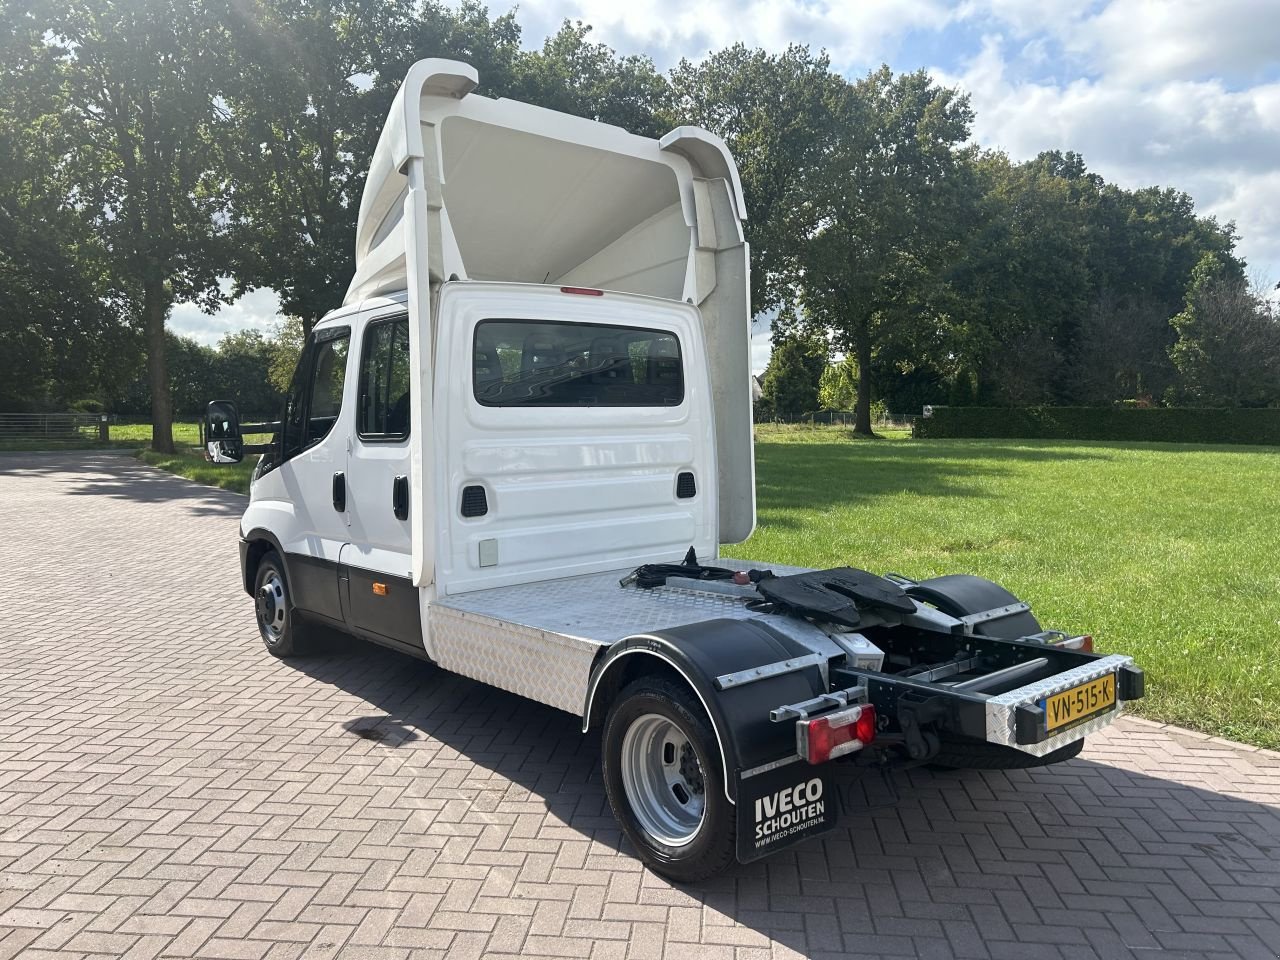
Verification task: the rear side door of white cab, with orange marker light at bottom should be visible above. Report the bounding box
[342,312,422,653]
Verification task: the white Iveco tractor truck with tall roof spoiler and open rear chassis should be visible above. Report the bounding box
[205,60,1143,881]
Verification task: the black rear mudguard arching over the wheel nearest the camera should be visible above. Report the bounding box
[582,620,827,803]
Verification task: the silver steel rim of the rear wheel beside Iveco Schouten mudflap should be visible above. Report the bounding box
[622,713,707,846]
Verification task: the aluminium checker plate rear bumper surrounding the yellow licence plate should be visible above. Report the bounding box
[986,654,1143,756]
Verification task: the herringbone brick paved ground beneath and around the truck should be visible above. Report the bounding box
[0,454,1280,960]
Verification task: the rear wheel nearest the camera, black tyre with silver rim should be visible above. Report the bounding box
[602,678,736,883]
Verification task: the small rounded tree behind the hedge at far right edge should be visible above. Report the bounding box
[1169,253,1280,407]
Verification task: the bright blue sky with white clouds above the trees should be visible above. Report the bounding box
[170,0,1280,371]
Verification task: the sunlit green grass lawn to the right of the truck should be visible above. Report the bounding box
[732,428,1280,749]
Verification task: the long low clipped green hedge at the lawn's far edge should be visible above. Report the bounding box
[911,407,1280,445]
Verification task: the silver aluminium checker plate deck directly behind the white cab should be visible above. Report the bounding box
[428,558,822,716]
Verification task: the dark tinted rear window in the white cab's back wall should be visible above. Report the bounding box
[471,320,685,407]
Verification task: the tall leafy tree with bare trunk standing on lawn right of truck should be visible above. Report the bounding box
[783,67,973,435]
